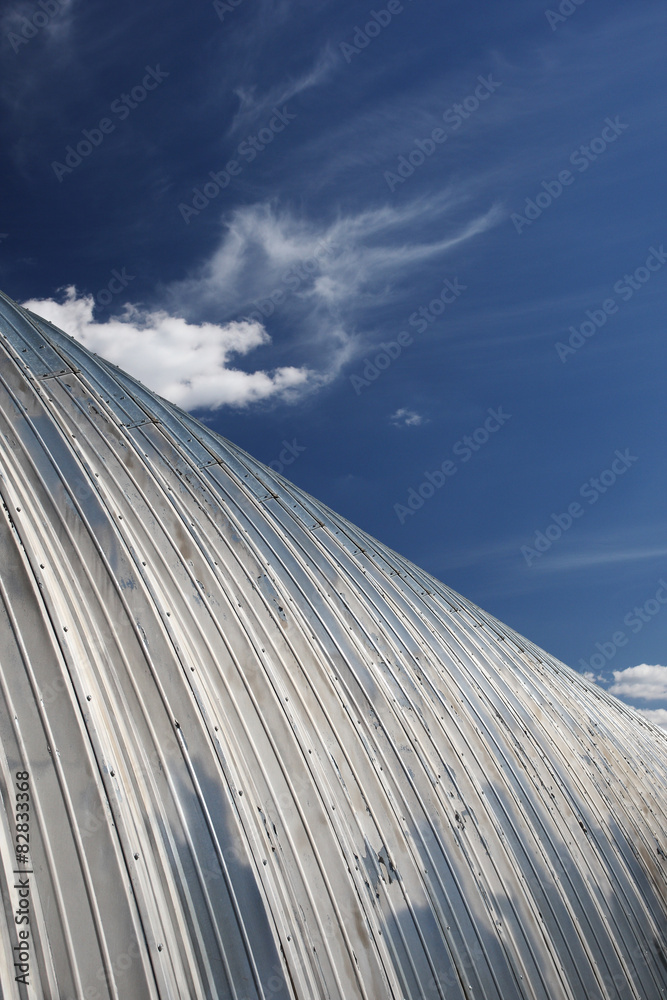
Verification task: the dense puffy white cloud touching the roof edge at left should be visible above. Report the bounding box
[22,286,322,409]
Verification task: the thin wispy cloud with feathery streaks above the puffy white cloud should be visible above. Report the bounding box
[168,191,501,377]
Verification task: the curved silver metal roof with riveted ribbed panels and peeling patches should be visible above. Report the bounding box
[0,286,667,1000]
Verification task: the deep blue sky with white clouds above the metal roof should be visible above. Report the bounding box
[0,0,667,724]
